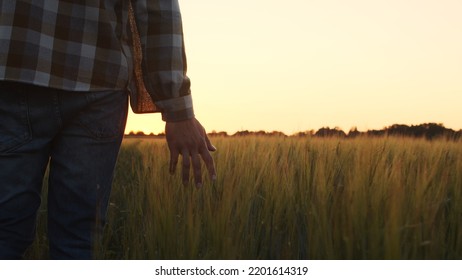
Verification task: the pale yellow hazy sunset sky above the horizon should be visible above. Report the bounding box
[127,0,462,134]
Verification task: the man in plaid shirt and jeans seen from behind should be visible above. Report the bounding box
[0,0,216,259]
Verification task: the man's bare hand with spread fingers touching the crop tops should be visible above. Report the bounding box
[165,118,217,187]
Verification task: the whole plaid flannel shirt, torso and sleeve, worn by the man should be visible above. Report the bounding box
[0,0,194,121]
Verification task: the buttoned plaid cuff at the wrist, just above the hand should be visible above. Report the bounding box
[155,95,194,122]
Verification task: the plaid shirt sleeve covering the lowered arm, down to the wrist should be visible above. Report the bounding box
[132,0,194,121]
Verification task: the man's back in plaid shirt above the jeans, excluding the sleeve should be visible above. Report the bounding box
[0,0,132,91]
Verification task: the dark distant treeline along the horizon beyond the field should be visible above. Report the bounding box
[128,123,462,140]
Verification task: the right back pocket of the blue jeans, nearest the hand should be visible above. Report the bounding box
[78,91,128,140]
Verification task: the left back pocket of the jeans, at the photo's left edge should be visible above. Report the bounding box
[0,87,32,154]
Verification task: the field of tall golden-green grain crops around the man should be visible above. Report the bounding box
[27,136,462,259]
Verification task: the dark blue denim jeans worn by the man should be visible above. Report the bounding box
[0,82,128,259]
